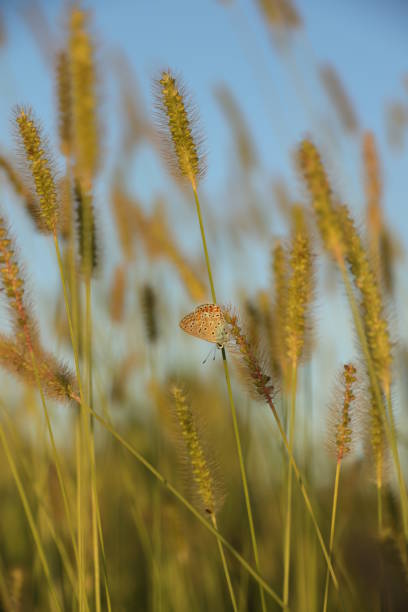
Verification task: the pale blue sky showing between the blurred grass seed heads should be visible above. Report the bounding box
[0,0,408,382]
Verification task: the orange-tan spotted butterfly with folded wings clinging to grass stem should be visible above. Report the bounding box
[179,304,228,348]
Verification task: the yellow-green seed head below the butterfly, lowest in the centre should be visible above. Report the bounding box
[171,385,219,515]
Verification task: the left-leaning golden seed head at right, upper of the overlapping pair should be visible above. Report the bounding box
[296,140,343,260]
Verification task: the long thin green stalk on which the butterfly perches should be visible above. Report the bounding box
[192,184,266,612]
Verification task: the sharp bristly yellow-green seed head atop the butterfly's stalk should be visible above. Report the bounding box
[155,70,205,189]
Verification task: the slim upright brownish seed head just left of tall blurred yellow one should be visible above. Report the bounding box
[56,51,72,157]
